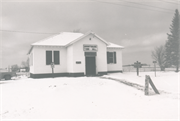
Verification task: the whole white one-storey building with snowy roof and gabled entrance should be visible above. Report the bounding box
[28,32,124,78]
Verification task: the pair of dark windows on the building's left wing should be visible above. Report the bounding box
[46,51,60,65]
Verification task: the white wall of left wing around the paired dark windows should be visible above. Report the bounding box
[31,46,67,74]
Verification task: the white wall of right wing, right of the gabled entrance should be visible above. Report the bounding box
[107,48,122,71]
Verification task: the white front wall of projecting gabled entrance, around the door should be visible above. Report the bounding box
[72,34,107,74]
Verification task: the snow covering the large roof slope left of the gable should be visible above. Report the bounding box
[32,32,83,46]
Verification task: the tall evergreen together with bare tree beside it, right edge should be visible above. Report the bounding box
[152,9,180,72]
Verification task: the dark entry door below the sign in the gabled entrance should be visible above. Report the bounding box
[86,57,96,76]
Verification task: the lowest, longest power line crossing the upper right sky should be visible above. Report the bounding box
[92,0,172,14]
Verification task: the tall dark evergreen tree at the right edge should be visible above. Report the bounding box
[165,9,180,72]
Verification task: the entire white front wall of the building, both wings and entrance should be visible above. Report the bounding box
[30,34,122,75]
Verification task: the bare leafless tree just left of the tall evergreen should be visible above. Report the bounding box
[151,45,166,71]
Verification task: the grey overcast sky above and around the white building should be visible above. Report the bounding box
[0,0,178,67]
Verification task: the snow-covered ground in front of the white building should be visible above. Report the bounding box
[0,72,180,121]
